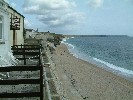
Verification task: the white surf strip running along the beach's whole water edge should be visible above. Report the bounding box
[63,37,133,81]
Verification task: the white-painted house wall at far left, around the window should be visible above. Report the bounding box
[0,0,11,65]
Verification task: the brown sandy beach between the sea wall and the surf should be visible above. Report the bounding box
[51,44,133,100]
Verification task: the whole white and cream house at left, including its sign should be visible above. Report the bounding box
[0,0,24,66]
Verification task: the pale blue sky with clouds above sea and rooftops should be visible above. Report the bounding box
[6,0,133,36]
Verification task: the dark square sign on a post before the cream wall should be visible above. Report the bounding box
[10,16,20,30]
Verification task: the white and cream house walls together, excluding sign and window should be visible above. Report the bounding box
[0,0,24,66]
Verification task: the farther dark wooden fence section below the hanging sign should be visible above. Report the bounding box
[11,45,42,65]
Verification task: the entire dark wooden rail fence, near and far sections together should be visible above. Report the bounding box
[0,45,44,100]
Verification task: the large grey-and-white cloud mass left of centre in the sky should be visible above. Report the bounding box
[23,0,84,28]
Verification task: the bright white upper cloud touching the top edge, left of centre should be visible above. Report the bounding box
[23,0,76,14]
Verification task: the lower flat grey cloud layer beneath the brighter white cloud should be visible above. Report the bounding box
[38,13,84,27]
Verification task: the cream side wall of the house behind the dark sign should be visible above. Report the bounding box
[8,7,24,45]
